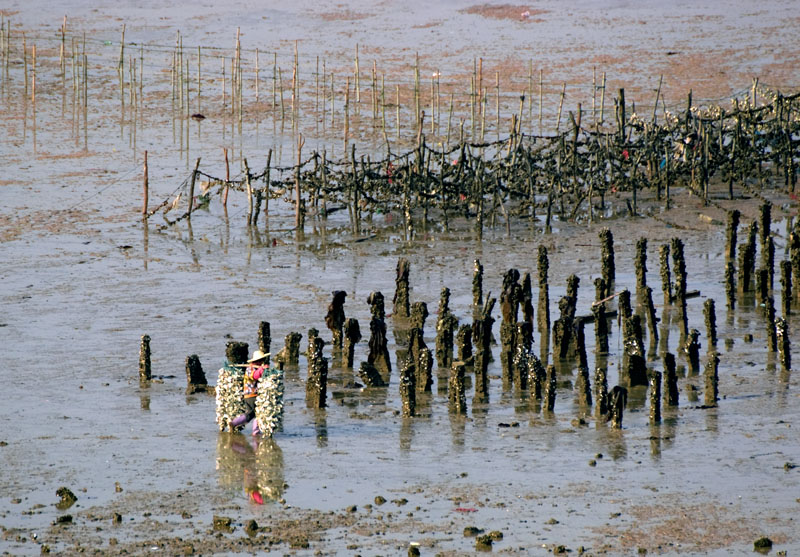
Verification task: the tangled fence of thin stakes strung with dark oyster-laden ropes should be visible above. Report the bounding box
[142,85,800,236]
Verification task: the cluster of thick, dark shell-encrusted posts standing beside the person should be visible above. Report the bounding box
[140,206,800,427]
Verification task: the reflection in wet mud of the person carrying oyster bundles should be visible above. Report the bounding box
[217,433,285,505]
